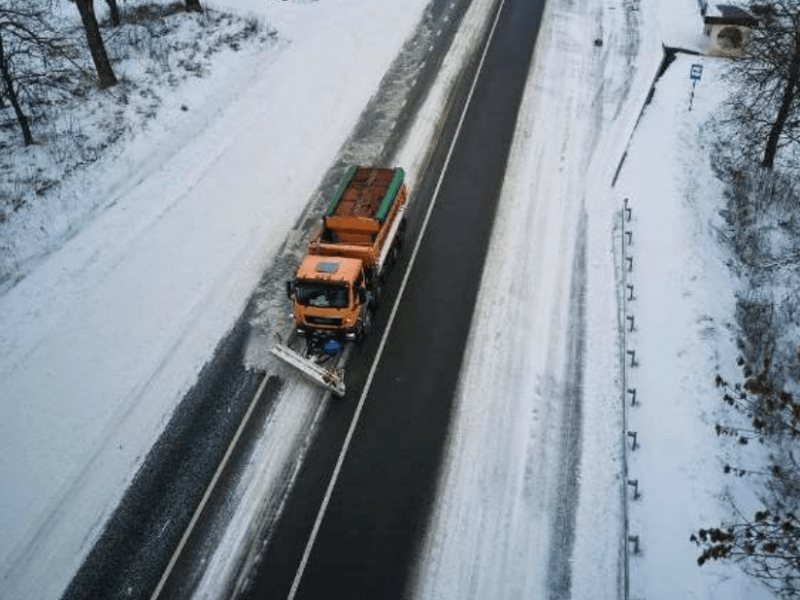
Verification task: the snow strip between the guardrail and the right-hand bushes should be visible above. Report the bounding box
[616,45,771,600]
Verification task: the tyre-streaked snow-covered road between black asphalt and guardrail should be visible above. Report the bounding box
[406,0,657,599]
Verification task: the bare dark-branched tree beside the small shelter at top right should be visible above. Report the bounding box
[730,0,800,169]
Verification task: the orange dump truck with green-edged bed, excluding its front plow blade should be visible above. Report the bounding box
[286,166,408,347]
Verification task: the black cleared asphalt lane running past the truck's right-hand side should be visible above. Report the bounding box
[241,0,544,598]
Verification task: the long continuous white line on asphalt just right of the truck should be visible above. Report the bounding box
[287,0,505,600]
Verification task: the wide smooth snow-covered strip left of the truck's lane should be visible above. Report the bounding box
[0,0,432,598]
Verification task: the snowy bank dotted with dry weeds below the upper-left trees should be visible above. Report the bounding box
[0,3,278,293]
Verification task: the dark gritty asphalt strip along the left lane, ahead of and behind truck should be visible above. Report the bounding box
[62,0,482,600]
